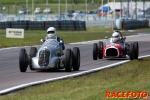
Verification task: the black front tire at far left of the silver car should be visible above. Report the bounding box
[19,49,28,72]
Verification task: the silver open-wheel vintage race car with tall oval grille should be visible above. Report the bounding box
[19,39,80,72]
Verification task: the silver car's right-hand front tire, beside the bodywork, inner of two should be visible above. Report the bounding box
[65,49,72,72]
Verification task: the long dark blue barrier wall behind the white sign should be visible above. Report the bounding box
[0,20,86,30]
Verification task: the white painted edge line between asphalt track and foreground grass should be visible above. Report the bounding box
[0,55,150,95]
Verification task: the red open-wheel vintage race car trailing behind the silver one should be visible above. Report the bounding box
[93,32,139,60]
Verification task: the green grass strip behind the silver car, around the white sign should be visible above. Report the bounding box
[0,27,111,48]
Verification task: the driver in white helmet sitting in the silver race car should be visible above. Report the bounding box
[43,27,65,50]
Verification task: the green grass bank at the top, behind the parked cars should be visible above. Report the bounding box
[0,0,113,14]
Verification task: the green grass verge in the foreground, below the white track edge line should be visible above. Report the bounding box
[0,57,150,100]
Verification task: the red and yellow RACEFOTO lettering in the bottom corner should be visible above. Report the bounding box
[106,91,148,99]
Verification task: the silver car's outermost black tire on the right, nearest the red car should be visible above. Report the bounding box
[72,47,80,71]
